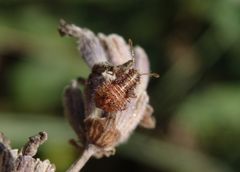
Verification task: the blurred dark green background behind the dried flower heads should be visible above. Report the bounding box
[0,0,240,172]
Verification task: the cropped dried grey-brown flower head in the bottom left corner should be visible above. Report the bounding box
[0,132,55,172]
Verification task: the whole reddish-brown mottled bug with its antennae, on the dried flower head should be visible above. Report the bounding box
[95,40,159,112]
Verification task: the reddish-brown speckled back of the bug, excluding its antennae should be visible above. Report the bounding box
[95,69,140,112]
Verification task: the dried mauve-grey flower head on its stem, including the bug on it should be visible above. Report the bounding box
[58,20,158,171]
